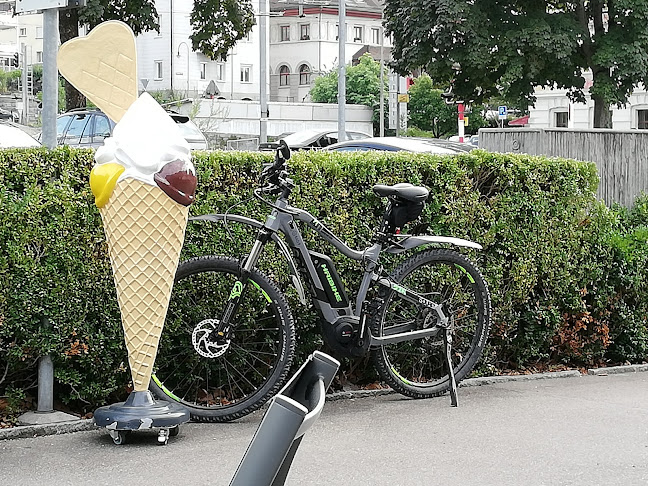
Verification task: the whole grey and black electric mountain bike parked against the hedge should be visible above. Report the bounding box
[151,144,490,422]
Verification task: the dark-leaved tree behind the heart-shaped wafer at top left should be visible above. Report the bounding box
[59,0,254,110]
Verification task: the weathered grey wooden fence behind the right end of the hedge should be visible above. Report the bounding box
[479,128,648,207]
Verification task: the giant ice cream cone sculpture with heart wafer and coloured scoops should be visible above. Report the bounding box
[58,21,196,438]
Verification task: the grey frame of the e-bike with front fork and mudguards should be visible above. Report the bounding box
[210,194,481,346]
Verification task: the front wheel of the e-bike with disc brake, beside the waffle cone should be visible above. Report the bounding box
[150,256,295,422]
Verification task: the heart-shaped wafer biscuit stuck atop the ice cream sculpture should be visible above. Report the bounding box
[58,20,137,122]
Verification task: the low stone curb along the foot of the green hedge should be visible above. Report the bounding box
[0,364,648,441]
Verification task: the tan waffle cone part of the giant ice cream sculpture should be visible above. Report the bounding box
[100,179,189,391]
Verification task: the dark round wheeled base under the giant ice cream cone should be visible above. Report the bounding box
[94,390,190,445]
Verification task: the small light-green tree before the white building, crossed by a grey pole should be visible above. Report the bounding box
[310,54,388,133]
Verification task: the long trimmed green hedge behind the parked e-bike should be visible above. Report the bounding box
[0,148,648,410]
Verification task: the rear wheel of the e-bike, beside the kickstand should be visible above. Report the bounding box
[371,249,490,398]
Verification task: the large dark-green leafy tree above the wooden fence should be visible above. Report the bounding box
[385,0,648,127]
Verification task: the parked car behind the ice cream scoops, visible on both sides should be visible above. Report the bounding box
[56,109,207,150]
